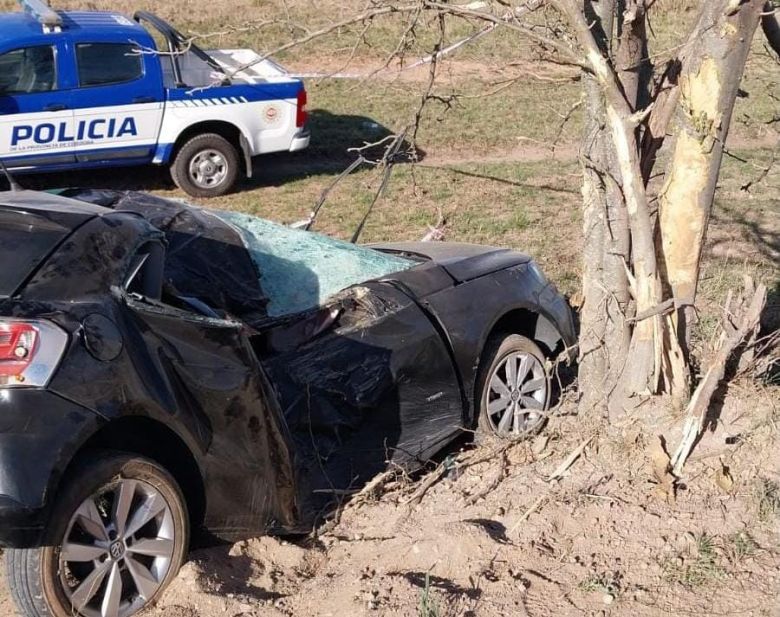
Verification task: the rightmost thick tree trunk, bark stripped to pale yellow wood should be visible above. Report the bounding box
[659,0,764,348]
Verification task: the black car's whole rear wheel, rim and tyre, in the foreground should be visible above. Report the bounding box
[6,453,189,617]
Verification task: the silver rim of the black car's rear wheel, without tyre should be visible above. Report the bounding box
[59,479,174,617]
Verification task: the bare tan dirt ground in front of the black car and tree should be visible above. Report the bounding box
[6,381,780,617]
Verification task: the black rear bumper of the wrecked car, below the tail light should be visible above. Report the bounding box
[0,389,102,548]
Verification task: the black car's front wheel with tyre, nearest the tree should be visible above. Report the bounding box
[477,334,551,439]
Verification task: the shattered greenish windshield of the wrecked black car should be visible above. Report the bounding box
[213,211,415,317]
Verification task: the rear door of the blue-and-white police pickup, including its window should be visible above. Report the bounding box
[71,39,165,163]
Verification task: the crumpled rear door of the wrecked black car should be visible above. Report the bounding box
[123,238,296,538]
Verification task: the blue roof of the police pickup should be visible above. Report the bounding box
[0,11,146,45]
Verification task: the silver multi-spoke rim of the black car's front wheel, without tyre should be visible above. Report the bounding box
[485,352,548,437]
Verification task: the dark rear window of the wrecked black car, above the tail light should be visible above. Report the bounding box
[0,209,70,298]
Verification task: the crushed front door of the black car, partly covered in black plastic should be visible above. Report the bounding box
[255,282,464,508]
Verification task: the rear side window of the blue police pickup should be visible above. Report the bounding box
[76,43,144,87]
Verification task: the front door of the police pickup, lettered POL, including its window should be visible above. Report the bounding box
[0,42,75,167]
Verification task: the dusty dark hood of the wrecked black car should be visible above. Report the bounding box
[371,242,531,283]
